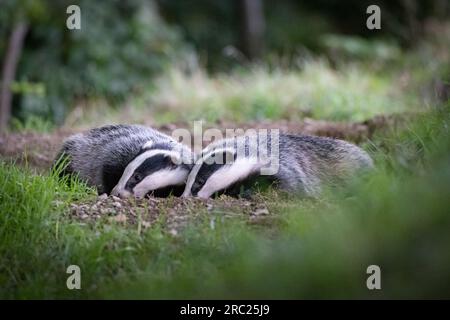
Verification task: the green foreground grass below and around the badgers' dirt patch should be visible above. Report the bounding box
[0,108,450,299]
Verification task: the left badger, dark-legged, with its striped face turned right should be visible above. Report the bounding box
[55,125,193,198]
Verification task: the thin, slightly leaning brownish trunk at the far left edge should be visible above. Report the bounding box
[0,22,28,132]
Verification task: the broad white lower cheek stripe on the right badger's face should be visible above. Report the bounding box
[197,158,261,199]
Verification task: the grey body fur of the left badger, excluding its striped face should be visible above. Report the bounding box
[57,125,192,194]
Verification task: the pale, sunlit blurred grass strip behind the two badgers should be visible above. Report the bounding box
[145,60,417,121]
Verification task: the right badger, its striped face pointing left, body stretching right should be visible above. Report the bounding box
[183,132,373,198]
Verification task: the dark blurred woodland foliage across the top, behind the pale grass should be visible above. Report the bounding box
[0,0,450,127]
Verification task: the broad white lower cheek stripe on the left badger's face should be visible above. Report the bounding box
[133,167,188,198]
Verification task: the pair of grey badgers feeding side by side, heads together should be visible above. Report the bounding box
[57,125,373,198]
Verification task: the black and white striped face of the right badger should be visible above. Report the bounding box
[183,149,260,199]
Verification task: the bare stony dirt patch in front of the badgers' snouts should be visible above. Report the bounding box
[70,194,271,236]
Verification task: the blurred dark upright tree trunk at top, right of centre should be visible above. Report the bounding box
[239,0,265,60]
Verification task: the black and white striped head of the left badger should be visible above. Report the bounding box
[111,143,191,198]
